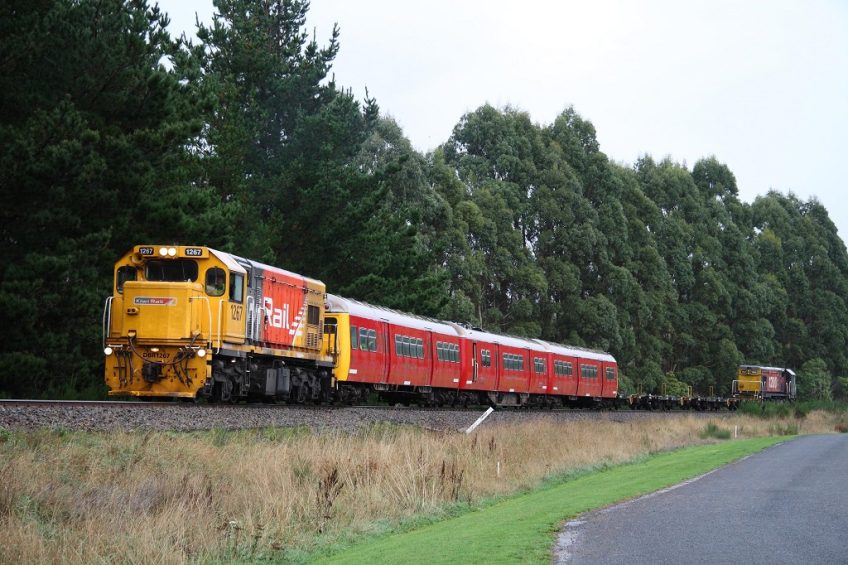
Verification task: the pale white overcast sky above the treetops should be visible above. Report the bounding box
[159,0,848,239]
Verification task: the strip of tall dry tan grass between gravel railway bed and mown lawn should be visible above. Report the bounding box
[0,413,837,563]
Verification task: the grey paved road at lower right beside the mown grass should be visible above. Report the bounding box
[554,434,848,565]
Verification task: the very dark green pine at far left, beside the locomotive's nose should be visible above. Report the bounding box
[0,0,209,395]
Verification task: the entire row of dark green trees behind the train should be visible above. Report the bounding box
[0,0,848,400]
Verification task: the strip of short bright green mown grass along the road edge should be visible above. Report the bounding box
[315,437,786,564]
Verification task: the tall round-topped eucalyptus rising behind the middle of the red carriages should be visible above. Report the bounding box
[441,105,545,336]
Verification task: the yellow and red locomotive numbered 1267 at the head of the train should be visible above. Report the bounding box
[103,245,335,402]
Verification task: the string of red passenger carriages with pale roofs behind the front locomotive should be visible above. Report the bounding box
[327,295,618,406]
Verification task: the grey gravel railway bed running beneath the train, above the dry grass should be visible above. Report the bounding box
[0,399,730,433]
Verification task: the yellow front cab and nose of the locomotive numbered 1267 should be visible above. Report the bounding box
[103,246,245,398]
